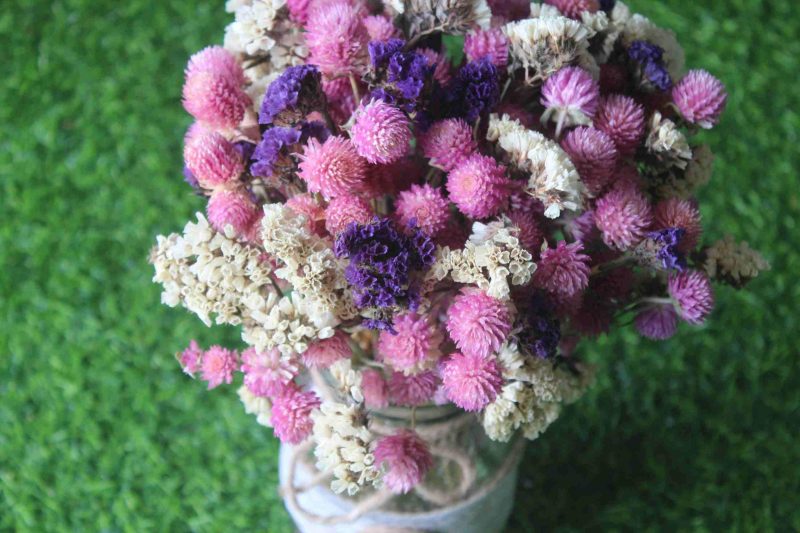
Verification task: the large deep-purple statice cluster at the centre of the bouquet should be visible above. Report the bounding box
[334,218,435,331]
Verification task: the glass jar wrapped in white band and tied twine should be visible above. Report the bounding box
[280,396,525,533]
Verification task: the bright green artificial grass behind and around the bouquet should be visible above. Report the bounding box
[0,0,800,531]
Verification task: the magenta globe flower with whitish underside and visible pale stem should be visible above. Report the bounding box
[541,67,600,137]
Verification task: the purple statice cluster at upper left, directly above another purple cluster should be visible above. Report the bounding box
[258,65,323,126]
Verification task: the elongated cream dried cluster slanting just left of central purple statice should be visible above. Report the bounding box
[261,204,357,326]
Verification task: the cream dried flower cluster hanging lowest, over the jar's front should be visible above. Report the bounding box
[311,402,381,496]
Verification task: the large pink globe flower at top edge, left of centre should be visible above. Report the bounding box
[305,0,369,77]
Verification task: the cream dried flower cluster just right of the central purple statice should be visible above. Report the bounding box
[426,217,536,301]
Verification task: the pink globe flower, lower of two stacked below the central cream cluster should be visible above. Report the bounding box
[440,352,503,411]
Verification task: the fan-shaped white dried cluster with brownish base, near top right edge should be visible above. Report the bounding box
[503,4,599,85]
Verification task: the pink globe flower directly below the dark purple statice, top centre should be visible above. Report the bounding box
[419,118,478,172]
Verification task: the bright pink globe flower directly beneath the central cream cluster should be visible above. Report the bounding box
[446,287,513,357]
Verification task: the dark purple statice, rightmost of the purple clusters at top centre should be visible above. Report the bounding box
[445,57,500,123]
